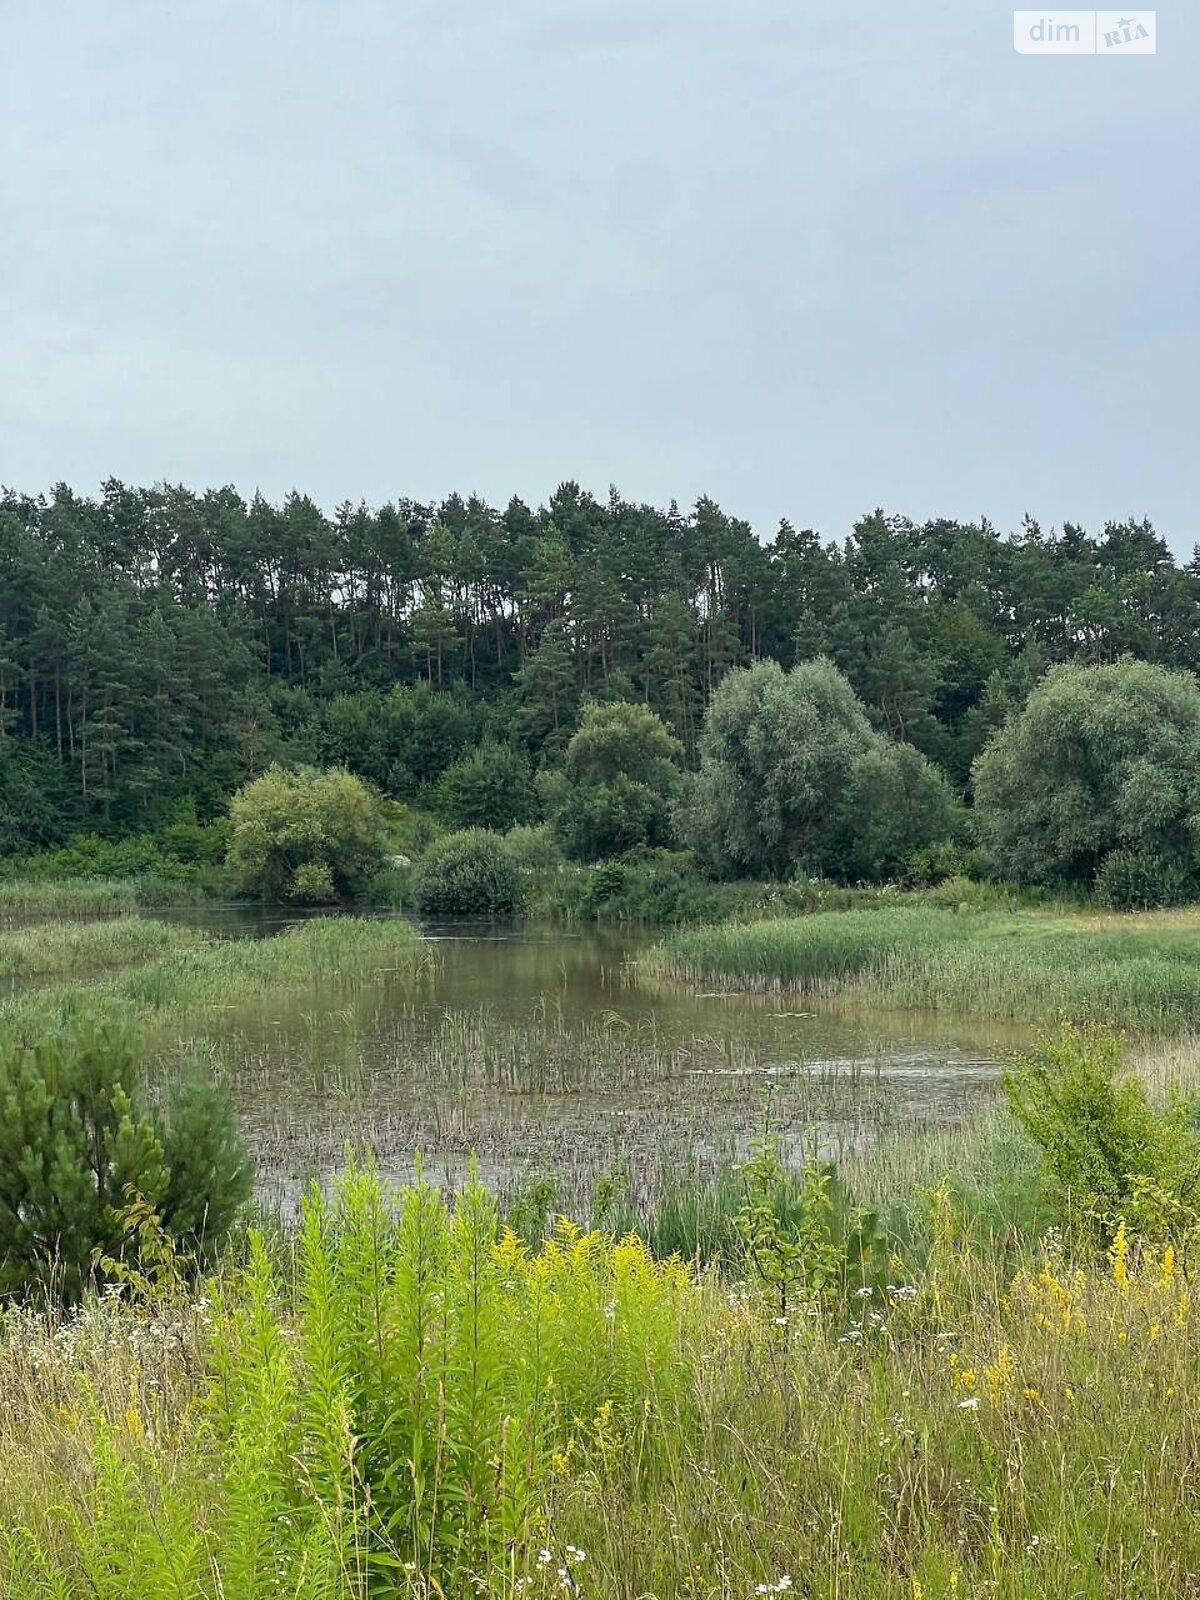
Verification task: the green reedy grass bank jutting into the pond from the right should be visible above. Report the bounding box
[645,907,1200,1034]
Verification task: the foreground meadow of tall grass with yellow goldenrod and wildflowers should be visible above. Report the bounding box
[0,1174,1200,1600]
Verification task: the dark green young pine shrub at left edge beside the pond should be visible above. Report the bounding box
[0,1021,251,1302]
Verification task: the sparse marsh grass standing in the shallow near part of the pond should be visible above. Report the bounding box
[213,982,934,1218]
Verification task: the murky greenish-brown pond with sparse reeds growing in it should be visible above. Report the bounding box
[157,912,1019,1211]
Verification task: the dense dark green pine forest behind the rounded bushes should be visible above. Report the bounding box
[0,480,1200,850]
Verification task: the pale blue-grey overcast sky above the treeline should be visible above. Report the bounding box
[0,0,1200,550]
